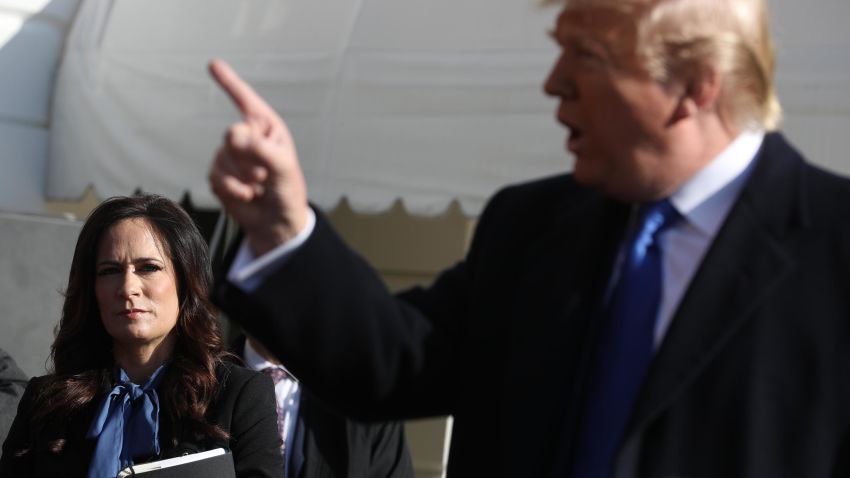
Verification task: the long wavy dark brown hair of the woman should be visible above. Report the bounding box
[24,195,227,451]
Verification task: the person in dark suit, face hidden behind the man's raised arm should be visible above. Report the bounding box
[232,335,413,478]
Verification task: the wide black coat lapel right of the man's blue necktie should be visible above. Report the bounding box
[627,131,805,436]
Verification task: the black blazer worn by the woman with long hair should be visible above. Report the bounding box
[0,363,283,478]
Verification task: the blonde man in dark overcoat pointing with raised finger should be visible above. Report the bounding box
[210,0,850,477]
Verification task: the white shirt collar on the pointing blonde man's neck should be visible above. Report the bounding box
[670,130,765,236]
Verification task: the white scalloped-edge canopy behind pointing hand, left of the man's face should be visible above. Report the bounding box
[47,0,567,214]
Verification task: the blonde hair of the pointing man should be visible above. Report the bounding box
[544,0,782,130]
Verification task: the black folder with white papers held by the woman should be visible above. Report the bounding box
[117,448,236,478]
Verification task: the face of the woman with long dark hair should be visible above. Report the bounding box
[95,218,180,347]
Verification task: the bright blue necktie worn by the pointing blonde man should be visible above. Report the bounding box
[573,200,680,478]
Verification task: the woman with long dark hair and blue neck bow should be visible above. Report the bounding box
[0,195,283,477]
